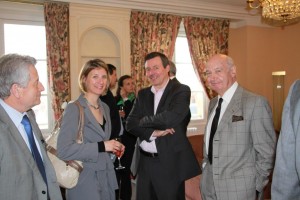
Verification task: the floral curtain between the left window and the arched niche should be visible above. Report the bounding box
[44,2,71,120]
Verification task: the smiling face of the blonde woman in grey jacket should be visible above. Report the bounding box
[83,68,108,96]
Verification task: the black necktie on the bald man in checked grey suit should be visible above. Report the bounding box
[208,98,223,164]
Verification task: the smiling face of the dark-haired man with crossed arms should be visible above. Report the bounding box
[145,56,170,89]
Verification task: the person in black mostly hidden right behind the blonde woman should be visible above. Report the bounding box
[100,64,123,139]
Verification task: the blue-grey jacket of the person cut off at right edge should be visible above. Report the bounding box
[271,80,300,200]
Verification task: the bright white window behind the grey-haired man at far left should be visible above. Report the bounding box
[4,23,49,129]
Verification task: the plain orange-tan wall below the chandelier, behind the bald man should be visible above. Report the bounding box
[229,23,300,111]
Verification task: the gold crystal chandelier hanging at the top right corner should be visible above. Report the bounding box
[247,0,300,22]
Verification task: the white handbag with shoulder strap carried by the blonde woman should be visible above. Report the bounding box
[46,101,84,189]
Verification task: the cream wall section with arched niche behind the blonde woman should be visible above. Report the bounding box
[70,4,130,100]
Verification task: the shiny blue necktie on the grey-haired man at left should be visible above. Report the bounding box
[21,115,47,184]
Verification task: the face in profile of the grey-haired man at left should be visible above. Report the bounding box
[17,65,44,112]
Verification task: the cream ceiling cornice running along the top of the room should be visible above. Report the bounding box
[7,0,265,28]
